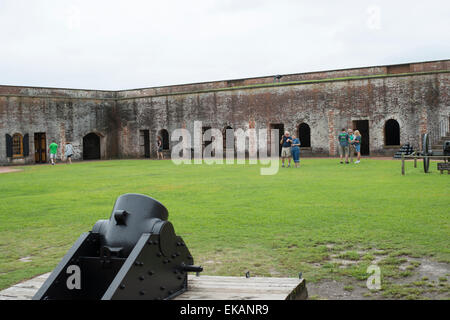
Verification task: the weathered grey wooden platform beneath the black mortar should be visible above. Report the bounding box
[0,273,308,300]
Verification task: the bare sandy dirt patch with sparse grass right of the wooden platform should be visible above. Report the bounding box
[307,245,450,300]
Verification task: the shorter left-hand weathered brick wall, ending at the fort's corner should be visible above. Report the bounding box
[0,95,117,164]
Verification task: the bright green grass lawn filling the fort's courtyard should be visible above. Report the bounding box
[0,159,450,297]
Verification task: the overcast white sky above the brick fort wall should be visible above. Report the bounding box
[0,0,450,90]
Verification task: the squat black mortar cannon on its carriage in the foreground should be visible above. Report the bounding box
[33,194,203,300]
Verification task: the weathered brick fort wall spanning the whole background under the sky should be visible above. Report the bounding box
[0,60,450,164]
